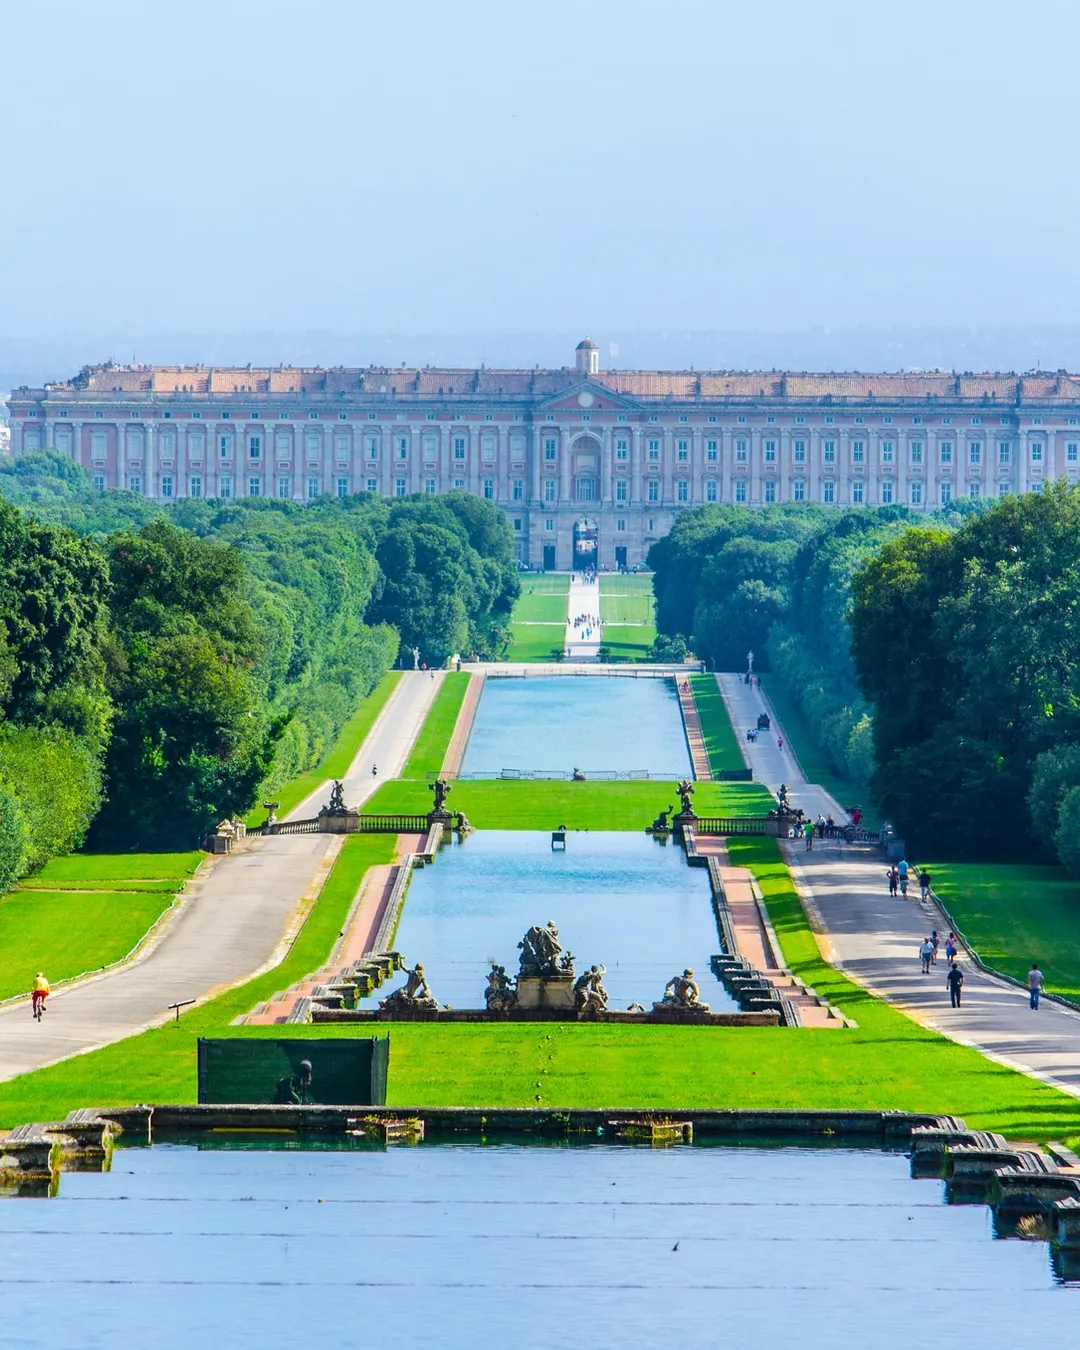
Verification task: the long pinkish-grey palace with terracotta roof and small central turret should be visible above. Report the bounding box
[11,339,1080,570]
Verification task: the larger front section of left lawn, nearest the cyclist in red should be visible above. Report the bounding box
[0,890,173,1004]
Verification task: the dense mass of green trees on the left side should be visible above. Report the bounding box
[0,452,520,853]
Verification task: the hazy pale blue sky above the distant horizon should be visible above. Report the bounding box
[0,0,1080,339]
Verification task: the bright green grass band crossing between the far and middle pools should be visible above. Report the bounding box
[365,779,776,830]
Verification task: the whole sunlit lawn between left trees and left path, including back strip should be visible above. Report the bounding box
[0,852,203,1004]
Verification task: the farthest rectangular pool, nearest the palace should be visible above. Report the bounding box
[462,675,691,780]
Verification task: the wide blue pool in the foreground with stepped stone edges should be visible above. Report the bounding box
[0,1135,1077,1350]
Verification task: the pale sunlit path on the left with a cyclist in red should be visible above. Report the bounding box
[0,671,440,1080]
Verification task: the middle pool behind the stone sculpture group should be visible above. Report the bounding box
[362,831,737,1011]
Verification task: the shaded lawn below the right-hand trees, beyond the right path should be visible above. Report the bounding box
[926,863,1080,1002]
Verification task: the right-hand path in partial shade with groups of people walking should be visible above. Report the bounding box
[717,675,1080,1096]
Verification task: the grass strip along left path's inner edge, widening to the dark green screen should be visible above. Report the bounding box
[0,834,396,1127]
